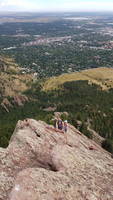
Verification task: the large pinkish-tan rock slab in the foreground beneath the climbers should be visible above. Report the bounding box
[0,119,113,200]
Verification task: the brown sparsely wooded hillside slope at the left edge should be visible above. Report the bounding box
[0,56,34,97]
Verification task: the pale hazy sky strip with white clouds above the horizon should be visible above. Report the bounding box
[0,0,113,12]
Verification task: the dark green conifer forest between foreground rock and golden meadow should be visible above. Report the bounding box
[0,81,113,153]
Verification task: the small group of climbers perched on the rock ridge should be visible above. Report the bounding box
[54,118,67,132]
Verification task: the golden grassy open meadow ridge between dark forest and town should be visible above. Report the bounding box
[43,67,113,91]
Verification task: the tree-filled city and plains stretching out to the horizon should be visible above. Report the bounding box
[0,13,113,77]
